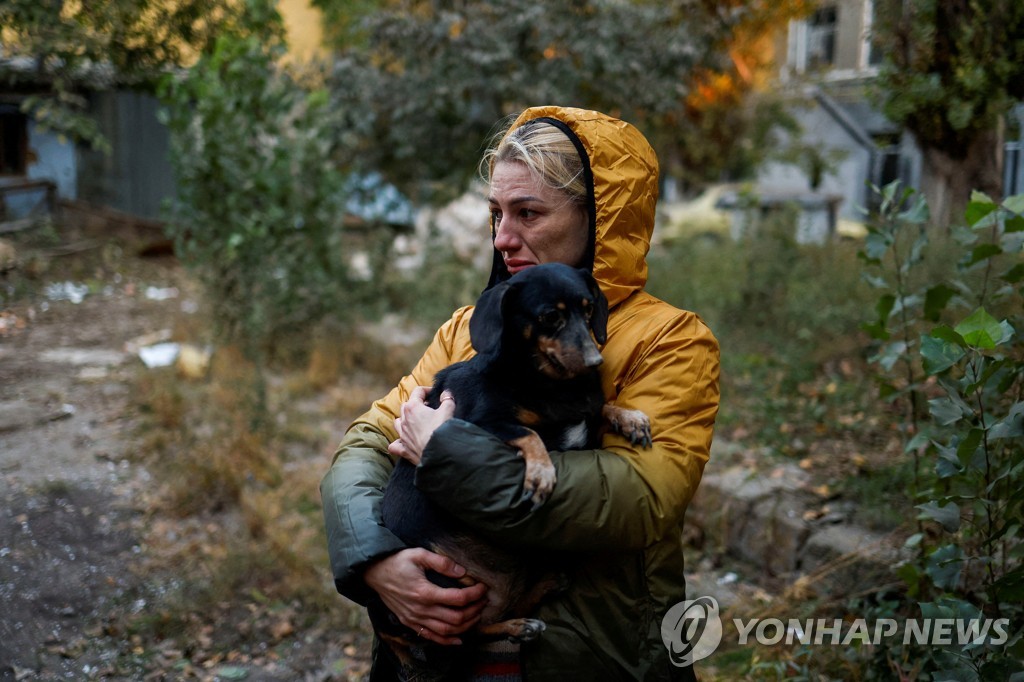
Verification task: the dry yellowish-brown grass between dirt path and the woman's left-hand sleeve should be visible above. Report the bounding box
[124,307,413,663]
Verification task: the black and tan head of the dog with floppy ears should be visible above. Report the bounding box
[469,263,608,379]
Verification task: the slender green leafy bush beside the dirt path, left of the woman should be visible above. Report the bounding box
[161,3,354,354]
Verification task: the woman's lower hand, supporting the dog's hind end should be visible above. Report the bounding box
[365,548,487,644]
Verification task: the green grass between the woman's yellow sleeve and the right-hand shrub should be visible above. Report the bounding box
[648,220,909,528]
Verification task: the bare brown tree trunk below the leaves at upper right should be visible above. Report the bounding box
[921,126,1004,227]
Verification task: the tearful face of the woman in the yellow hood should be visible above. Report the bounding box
[487,162,589,274]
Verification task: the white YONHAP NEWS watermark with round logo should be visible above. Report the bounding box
[662,597,1010,666]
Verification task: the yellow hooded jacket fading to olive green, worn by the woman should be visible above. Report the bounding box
[321,106,719,681]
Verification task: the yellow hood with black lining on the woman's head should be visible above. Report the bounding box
[488,106,658,306]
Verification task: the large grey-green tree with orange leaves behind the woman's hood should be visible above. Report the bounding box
[318,0,802,199]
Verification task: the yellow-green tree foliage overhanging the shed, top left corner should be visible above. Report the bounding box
[0,0,240,150]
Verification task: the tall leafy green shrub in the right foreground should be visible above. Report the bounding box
[863,184,1024,679]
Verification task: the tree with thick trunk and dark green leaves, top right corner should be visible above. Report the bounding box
[872,0,1024,225]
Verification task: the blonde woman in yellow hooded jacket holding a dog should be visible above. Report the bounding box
[321,106,719,680]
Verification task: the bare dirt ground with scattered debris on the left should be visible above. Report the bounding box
[0,220,376,680]
